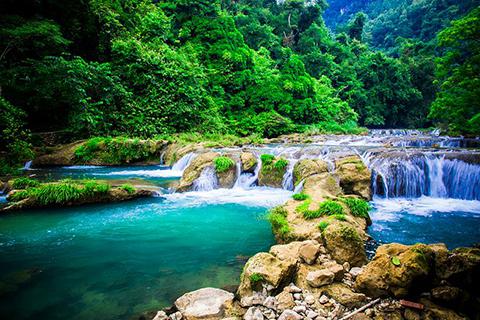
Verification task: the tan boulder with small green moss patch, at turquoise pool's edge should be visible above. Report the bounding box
[238,252,297,297]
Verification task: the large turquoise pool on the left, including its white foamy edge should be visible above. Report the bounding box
[0,190,290,320]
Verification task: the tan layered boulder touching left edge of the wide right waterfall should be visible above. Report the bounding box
[335,156,372,200]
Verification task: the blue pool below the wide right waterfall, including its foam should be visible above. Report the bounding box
[368,197,480,249]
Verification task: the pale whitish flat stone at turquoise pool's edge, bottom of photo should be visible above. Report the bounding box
[175,288,234,320]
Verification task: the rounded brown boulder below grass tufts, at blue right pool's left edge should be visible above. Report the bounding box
[323,222,367,267]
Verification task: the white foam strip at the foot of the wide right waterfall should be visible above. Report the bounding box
[370,196,480,221]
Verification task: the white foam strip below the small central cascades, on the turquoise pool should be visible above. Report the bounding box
[164,187,292,208]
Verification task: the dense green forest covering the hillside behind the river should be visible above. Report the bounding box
[0,0,480,172]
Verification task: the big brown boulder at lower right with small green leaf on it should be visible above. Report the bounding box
[355,243,434,297]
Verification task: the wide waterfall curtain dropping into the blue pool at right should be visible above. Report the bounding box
[363,154,480,200]
